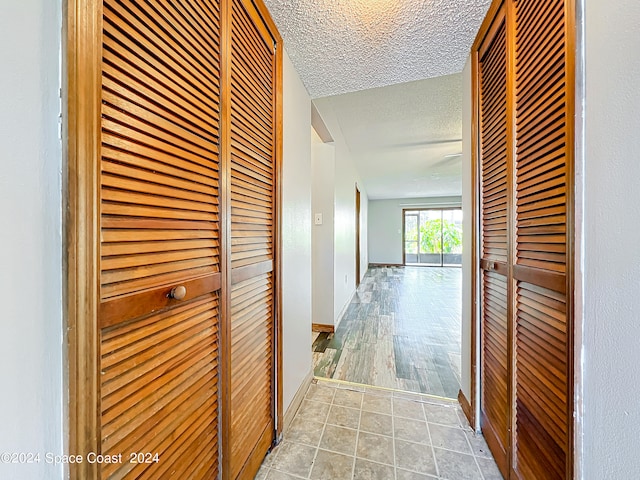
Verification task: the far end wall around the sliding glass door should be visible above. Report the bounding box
[368,197,462,265]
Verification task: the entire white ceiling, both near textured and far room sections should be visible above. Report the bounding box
[265,0,491,199]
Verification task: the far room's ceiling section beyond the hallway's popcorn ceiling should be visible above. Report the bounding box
[314,73,462,199]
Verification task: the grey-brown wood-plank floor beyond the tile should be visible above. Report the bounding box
[313,267,462,398]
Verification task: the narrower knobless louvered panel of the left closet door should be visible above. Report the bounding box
[228,0,276,478]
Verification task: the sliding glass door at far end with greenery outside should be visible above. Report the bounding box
[402,208,462,267]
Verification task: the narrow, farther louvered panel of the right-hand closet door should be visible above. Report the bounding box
[478,10,511,472]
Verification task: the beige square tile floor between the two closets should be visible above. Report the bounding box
[256,379,502,480]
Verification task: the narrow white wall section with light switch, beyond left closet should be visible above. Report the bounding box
[311,129,336,326]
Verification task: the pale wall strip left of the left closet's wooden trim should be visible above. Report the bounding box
[0,0,64,480]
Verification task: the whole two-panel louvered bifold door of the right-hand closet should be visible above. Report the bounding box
[474,0,574,480]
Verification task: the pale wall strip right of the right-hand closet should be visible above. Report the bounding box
[578,0,640,474]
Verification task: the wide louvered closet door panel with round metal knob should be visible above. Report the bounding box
[99,0,220,479]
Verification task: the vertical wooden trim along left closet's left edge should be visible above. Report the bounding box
[63,0,102,479]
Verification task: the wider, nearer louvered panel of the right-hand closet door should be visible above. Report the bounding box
[513,0,573,479]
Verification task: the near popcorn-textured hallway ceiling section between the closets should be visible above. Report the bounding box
[265,0,491,98]
